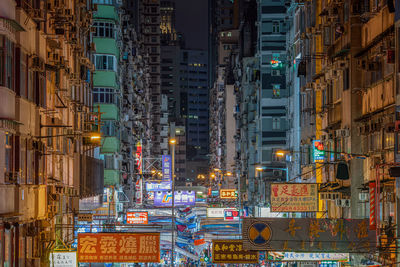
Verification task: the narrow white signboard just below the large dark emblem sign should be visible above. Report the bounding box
[281,252,349,261]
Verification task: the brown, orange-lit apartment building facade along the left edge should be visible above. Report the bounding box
[0,0,103,266]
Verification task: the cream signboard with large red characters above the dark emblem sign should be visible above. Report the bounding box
[271,183,318,212]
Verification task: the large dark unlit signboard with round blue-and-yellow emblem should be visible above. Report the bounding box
[242,218,377,253]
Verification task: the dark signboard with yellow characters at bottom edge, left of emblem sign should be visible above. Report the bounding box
[212,239,258,263]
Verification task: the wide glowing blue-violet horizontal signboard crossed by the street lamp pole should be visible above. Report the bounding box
[154,191,196,207]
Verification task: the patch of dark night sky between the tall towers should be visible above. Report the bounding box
[175,0,208,49]
